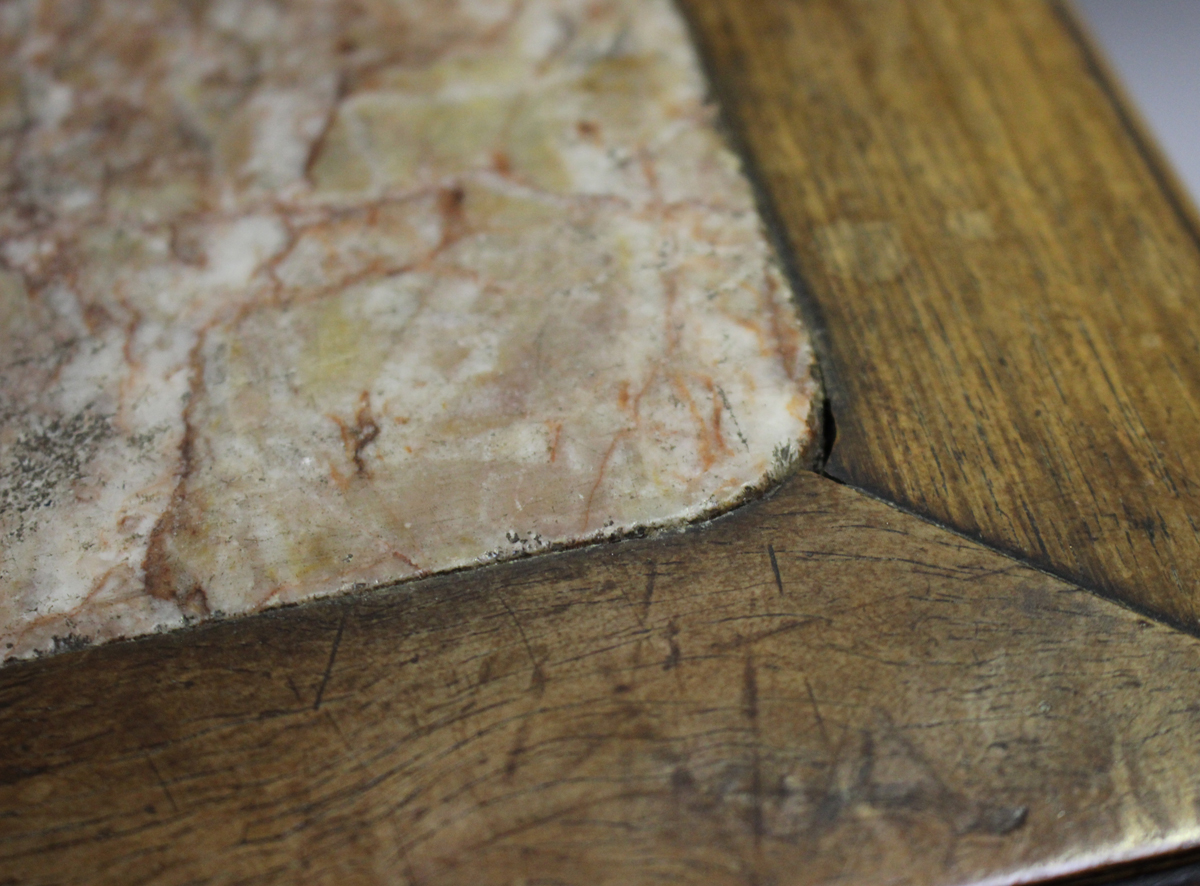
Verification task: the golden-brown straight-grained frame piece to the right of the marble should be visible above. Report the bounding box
[682,0,1200,631]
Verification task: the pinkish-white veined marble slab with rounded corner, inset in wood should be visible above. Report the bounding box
[0,0,815,659]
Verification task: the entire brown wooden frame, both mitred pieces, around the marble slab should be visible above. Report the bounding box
[0,0,1200,886]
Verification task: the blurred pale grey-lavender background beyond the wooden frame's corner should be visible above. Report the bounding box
[1075,0,1200,204]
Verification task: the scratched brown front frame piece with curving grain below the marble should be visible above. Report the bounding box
[0,474,1200,886]
